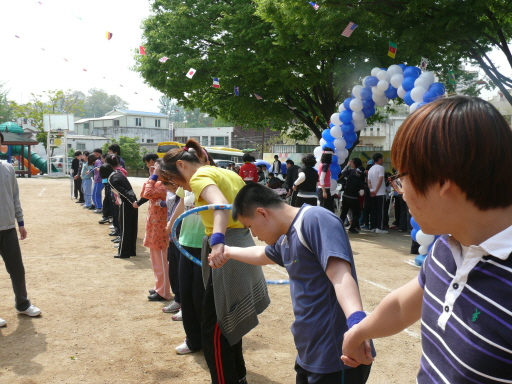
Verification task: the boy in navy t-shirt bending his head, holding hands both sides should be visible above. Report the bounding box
[209,184,371,384]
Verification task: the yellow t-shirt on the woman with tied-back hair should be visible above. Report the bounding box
[190,165,245,236]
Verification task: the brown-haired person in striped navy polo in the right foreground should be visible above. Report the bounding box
[342,96,512,384]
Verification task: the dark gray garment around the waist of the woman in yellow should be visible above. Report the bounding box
[201,228,270,345]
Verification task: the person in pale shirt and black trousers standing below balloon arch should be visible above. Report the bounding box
[368,153,388,233]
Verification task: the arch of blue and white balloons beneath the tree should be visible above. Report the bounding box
[314,64,446,265]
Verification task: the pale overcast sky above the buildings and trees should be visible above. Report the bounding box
[0,0,511,112]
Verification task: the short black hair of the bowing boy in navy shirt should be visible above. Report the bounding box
[231,183,286,220]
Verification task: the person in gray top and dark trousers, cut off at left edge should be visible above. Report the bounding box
[0,132,41,327]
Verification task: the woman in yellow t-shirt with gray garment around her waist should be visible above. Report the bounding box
[159,139,270,384]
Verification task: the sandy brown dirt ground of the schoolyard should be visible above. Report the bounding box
[0,178,421,384]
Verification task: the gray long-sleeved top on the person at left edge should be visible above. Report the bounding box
[0,161,23,231]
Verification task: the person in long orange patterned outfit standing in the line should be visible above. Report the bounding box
[140,159,171,301]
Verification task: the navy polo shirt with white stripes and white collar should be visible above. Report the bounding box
[417,226,512,384]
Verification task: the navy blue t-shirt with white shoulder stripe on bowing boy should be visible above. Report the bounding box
[265,204,357,373]
